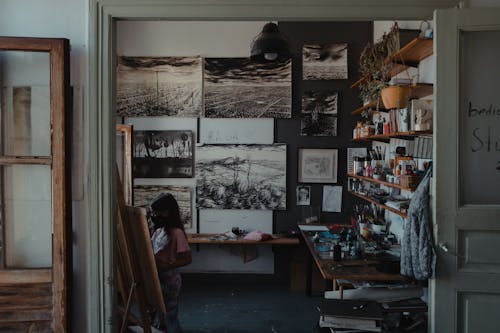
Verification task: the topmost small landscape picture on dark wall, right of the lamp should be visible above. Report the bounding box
[302,43,347,80]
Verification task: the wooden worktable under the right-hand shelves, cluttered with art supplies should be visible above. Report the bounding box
[300,226,403,295]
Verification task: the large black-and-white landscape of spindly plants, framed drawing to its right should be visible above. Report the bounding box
[196,144,286,210]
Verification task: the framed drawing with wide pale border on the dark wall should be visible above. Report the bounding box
[298,148,338,183]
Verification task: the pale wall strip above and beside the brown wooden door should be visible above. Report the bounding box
[0,0,91,332]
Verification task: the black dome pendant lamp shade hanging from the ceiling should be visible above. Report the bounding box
[250,23,291,62]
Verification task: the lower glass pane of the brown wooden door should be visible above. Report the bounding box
[2,165,52,268]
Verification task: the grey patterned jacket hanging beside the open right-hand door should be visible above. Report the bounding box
[401,167,436,280]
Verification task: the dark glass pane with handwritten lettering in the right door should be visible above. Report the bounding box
[458,31,500,204]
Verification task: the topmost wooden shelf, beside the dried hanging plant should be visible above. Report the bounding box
[351,37,433,88]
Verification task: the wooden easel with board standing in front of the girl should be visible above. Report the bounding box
[116,168,166,333]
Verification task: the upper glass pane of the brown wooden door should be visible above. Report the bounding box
[0,51,50,156]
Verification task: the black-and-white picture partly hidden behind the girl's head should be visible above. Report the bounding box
[134,185,193,230]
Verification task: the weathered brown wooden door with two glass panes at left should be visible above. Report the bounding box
[0,37,71,332]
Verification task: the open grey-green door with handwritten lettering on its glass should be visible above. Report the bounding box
[429,8,500,333]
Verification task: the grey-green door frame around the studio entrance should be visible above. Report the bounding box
[90,0,460,332]
